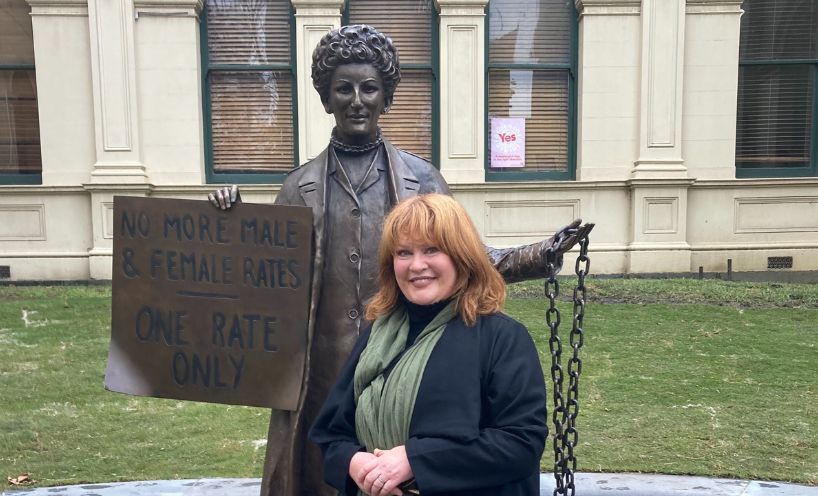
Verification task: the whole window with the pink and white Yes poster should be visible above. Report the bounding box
[486,0,577,181]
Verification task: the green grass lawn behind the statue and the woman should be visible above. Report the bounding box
[0,278,818,485]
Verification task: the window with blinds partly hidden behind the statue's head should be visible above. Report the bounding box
[344,0,438,163]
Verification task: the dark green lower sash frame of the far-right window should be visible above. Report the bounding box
[735,57,818,179]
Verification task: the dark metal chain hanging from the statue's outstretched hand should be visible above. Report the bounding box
[545,236,591,496]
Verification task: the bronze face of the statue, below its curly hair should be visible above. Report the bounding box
[324,64,390,145]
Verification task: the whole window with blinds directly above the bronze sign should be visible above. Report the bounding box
[202,0,298,183]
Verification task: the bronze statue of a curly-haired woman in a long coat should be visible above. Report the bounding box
[209,25,590,496]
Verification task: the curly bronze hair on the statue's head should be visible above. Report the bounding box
[312,24,400,103]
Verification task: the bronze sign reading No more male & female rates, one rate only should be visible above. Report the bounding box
[105,196,312,410]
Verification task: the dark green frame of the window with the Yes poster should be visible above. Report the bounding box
[483,2,579,182]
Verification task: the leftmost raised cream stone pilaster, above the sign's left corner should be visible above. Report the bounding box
[88,0,148,184]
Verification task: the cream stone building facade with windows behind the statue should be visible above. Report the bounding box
[0,0,818,281]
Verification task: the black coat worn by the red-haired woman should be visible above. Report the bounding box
[310,314,548,496]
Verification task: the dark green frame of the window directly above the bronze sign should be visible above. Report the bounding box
[199,0,300,184]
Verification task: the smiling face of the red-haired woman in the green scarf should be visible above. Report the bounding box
[392,236,457,305]
